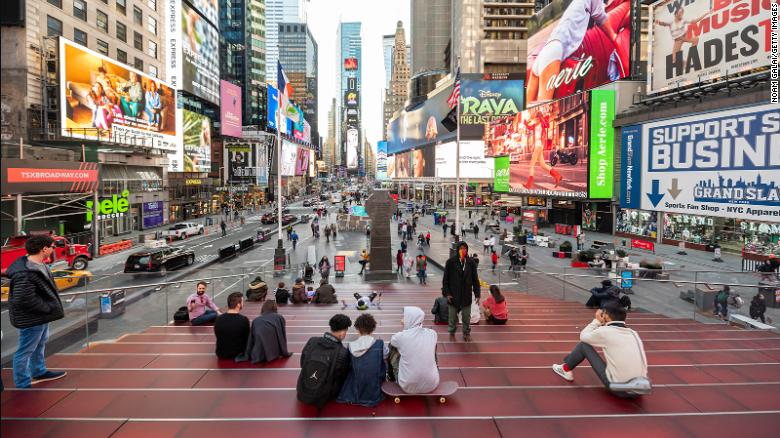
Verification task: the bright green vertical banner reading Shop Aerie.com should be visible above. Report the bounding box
[588,90,615,199]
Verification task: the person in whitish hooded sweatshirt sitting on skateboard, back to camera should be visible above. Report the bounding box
[390,307,439,394]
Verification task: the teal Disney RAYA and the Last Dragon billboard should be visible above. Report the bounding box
[460,73,525,140]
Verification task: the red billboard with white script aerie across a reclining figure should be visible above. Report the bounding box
[526,0,631,106]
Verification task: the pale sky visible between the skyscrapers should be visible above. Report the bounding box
[304,0,411,148]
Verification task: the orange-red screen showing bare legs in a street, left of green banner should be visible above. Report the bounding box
[485,93,590,198]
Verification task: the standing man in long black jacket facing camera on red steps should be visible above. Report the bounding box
[442,242,479,342]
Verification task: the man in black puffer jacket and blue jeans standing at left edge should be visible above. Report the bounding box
[6,236,66,388]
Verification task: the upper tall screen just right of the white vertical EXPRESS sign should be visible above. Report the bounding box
[179,0,219,104]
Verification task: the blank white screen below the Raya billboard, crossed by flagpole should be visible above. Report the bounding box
[435,140,493,179]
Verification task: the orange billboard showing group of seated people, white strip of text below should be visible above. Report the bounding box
[59,37,176,151]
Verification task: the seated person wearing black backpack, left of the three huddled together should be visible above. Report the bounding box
[296,314,352,408]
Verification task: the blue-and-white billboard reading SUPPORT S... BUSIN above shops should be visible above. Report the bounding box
[621,104,780,222]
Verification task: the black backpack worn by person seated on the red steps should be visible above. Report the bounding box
[297,338,343,408]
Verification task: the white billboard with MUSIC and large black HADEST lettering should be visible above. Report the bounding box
[647,0,776,93]
